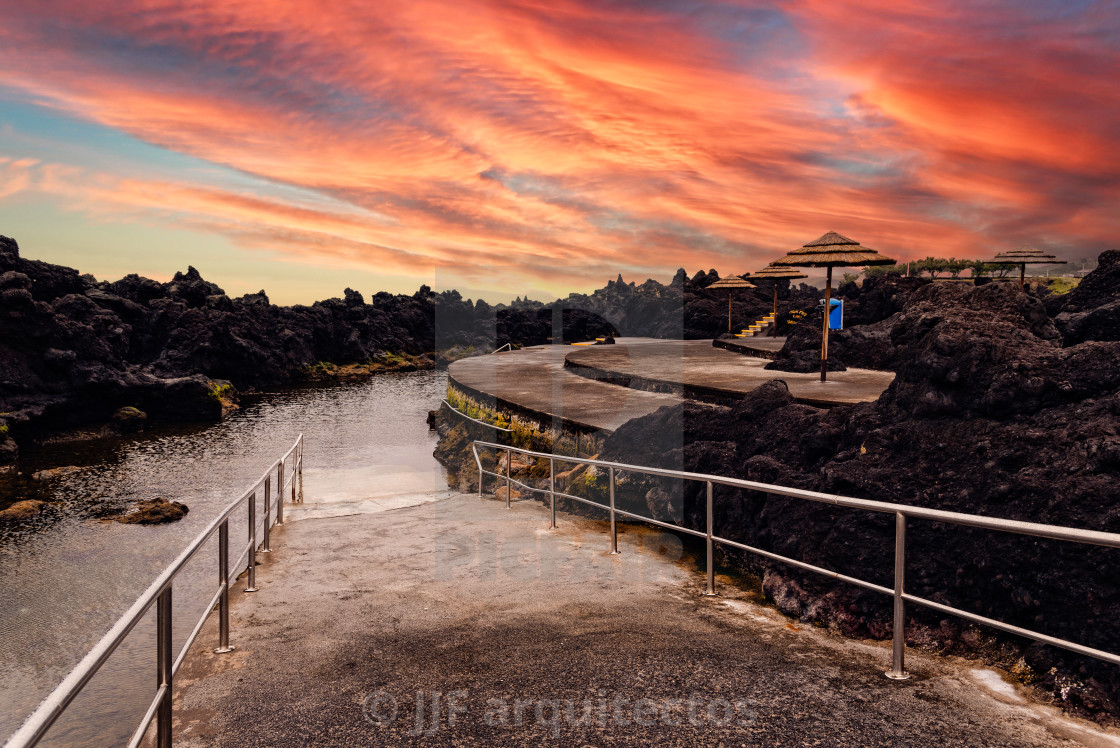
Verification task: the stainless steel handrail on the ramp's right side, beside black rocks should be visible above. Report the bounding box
[470,440,1120,680]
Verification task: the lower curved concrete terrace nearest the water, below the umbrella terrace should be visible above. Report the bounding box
[447,345,681,431]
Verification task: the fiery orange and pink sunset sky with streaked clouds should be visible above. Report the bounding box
[0,0,1120,303]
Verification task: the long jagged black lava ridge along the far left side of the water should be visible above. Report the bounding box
[0,237,812,461]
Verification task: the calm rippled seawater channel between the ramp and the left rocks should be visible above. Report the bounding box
[0,372,447,746]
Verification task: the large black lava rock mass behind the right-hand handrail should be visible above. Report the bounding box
[601,268,1120,713]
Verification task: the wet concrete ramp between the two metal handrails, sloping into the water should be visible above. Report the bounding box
[175,495,1120,748]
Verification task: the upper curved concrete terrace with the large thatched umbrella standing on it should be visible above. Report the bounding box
[567,338,895,405]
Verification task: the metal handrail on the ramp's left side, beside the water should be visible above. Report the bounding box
[4,433,304,748]
